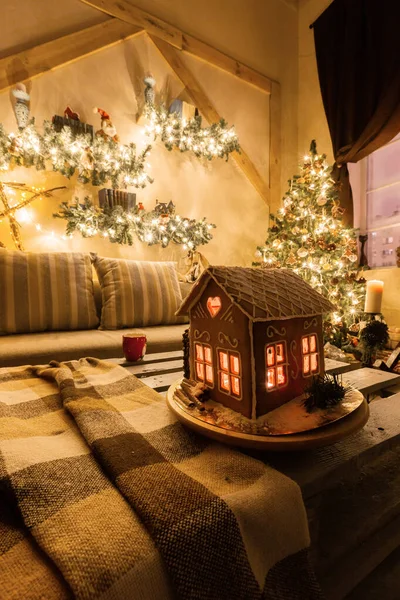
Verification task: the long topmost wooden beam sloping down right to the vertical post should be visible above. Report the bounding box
[81,0,272,94]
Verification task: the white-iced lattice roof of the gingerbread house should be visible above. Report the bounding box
[176,266,336,321]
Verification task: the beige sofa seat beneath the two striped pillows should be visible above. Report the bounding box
[0,251,190,367]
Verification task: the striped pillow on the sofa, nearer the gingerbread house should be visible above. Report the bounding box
[93,256,186,329]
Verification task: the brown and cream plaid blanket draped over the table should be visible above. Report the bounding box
[0,359,320,600]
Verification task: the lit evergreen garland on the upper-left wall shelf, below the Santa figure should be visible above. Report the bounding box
[0,119,153,188]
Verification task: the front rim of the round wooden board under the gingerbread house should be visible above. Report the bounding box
[167,380,369,452]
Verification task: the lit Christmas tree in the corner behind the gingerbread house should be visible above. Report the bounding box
[253,140,365,346]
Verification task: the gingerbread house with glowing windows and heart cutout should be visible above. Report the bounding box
[177,266,335,419]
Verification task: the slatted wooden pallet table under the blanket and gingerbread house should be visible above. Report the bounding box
[108,352,400,600]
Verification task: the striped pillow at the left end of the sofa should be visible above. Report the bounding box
[0,248,99,335]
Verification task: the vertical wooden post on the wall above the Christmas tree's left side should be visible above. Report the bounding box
[269,81,282,213]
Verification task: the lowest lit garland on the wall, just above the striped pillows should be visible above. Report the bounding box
[54,198,215,251]
